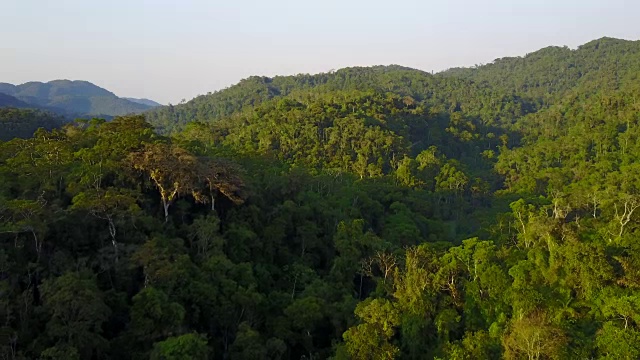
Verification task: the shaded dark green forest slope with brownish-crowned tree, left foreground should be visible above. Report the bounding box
[0,113,480,359]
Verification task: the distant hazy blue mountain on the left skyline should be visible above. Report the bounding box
[0,80,154,116]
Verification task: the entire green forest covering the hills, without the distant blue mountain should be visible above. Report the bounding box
[0,38,640,360]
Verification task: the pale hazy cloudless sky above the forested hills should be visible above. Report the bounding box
[0,0,640,103]
